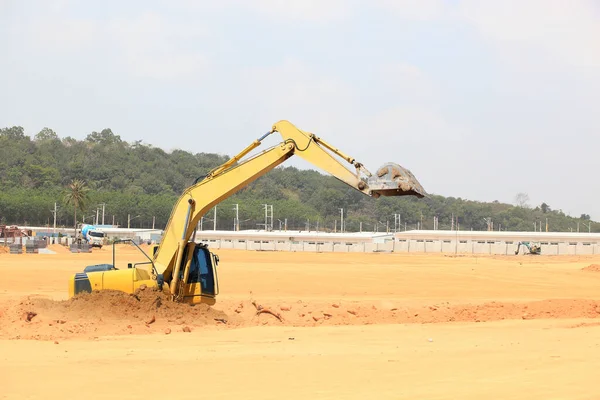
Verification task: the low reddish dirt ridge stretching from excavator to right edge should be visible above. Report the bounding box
[220,299,600,326]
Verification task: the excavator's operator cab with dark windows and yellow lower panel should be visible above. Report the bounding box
[184,245,219,303]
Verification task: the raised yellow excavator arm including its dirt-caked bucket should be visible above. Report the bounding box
[153,121,427,294]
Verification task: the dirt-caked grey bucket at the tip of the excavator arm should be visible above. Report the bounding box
[367,163,428,198]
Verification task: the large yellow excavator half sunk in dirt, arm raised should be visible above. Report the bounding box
[69,120,427,305]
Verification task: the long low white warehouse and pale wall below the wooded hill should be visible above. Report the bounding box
[15,227,600,255]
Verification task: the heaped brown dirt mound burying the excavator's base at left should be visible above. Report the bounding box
[0,288,227,340]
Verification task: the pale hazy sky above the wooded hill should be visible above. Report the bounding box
[0,0,600,220]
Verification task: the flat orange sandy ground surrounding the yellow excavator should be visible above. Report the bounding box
[0,246,600,399]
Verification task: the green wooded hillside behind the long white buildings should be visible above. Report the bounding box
[0,126,600,232]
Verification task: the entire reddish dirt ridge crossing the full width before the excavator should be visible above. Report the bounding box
[0,288,600,340]
